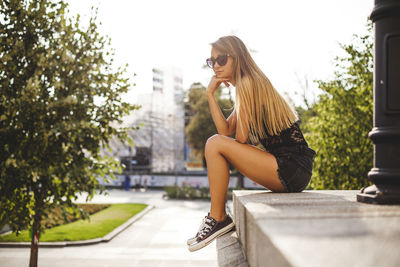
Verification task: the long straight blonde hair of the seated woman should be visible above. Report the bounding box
[211,36,298,141]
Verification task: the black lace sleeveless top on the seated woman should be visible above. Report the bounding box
[250,122,308,151]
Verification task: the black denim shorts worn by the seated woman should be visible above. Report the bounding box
[269,145,315,193]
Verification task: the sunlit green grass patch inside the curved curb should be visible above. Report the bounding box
[0,204,147,242]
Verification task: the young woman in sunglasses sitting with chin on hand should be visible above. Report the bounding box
[187,36,315,251]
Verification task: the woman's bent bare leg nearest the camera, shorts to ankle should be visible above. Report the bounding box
[205,134,284,221]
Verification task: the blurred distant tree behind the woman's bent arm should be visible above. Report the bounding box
[185,83,233,156]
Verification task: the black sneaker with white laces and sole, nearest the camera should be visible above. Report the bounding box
[189,215,235,251]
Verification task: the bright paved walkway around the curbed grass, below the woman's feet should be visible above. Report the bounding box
[0,190,222,267]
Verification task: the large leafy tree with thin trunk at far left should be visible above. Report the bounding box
[0,0,137,266]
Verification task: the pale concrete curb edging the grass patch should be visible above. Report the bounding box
[0,205,154,248]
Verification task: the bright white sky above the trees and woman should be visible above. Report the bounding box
[67,0,374,105]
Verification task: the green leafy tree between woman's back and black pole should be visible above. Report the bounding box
[303,25,373,189]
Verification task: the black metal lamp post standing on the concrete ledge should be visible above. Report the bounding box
[357,0,400,204]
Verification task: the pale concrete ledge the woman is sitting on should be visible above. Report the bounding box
[233,190,400,267]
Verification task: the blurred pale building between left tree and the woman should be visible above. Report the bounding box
[104,67,185,175]
